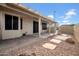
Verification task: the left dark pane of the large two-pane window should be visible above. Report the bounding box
[5,14,12,30]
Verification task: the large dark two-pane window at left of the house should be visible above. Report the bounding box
[5,14,18,30]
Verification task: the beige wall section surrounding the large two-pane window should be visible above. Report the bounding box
[1,11,21,39]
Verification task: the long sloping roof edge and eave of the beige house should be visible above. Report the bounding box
[0,3,56,23]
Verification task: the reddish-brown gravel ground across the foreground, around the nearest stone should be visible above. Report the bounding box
[0,34,79,56]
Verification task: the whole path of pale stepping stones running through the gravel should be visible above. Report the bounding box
[43,34,71,49]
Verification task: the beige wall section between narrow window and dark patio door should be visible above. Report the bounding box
[22,16,33,35]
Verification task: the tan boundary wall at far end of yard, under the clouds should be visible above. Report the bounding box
[59,25,74,34]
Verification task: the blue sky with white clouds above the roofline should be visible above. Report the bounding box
[22,3,79,25]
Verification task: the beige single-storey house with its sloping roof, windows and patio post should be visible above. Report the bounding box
[0,3,56,40]
